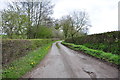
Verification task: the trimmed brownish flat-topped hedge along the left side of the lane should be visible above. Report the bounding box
[2,39,52,67]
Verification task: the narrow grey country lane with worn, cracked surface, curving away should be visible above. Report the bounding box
[23,41,118,78]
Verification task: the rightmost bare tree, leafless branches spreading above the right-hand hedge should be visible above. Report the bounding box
[71,11,91,37]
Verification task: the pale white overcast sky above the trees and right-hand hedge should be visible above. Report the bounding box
[0,0,119,34]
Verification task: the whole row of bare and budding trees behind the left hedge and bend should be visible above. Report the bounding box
[2,0,91,39]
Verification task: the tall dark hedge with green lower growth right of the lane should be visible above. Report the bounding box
[65,31,120,55]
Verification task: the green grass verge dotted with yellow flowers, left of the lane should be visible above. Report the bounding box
[2,42,53,79]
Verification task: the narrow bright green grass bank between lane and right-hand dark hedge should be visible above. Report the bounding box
[62,42,120,65]
